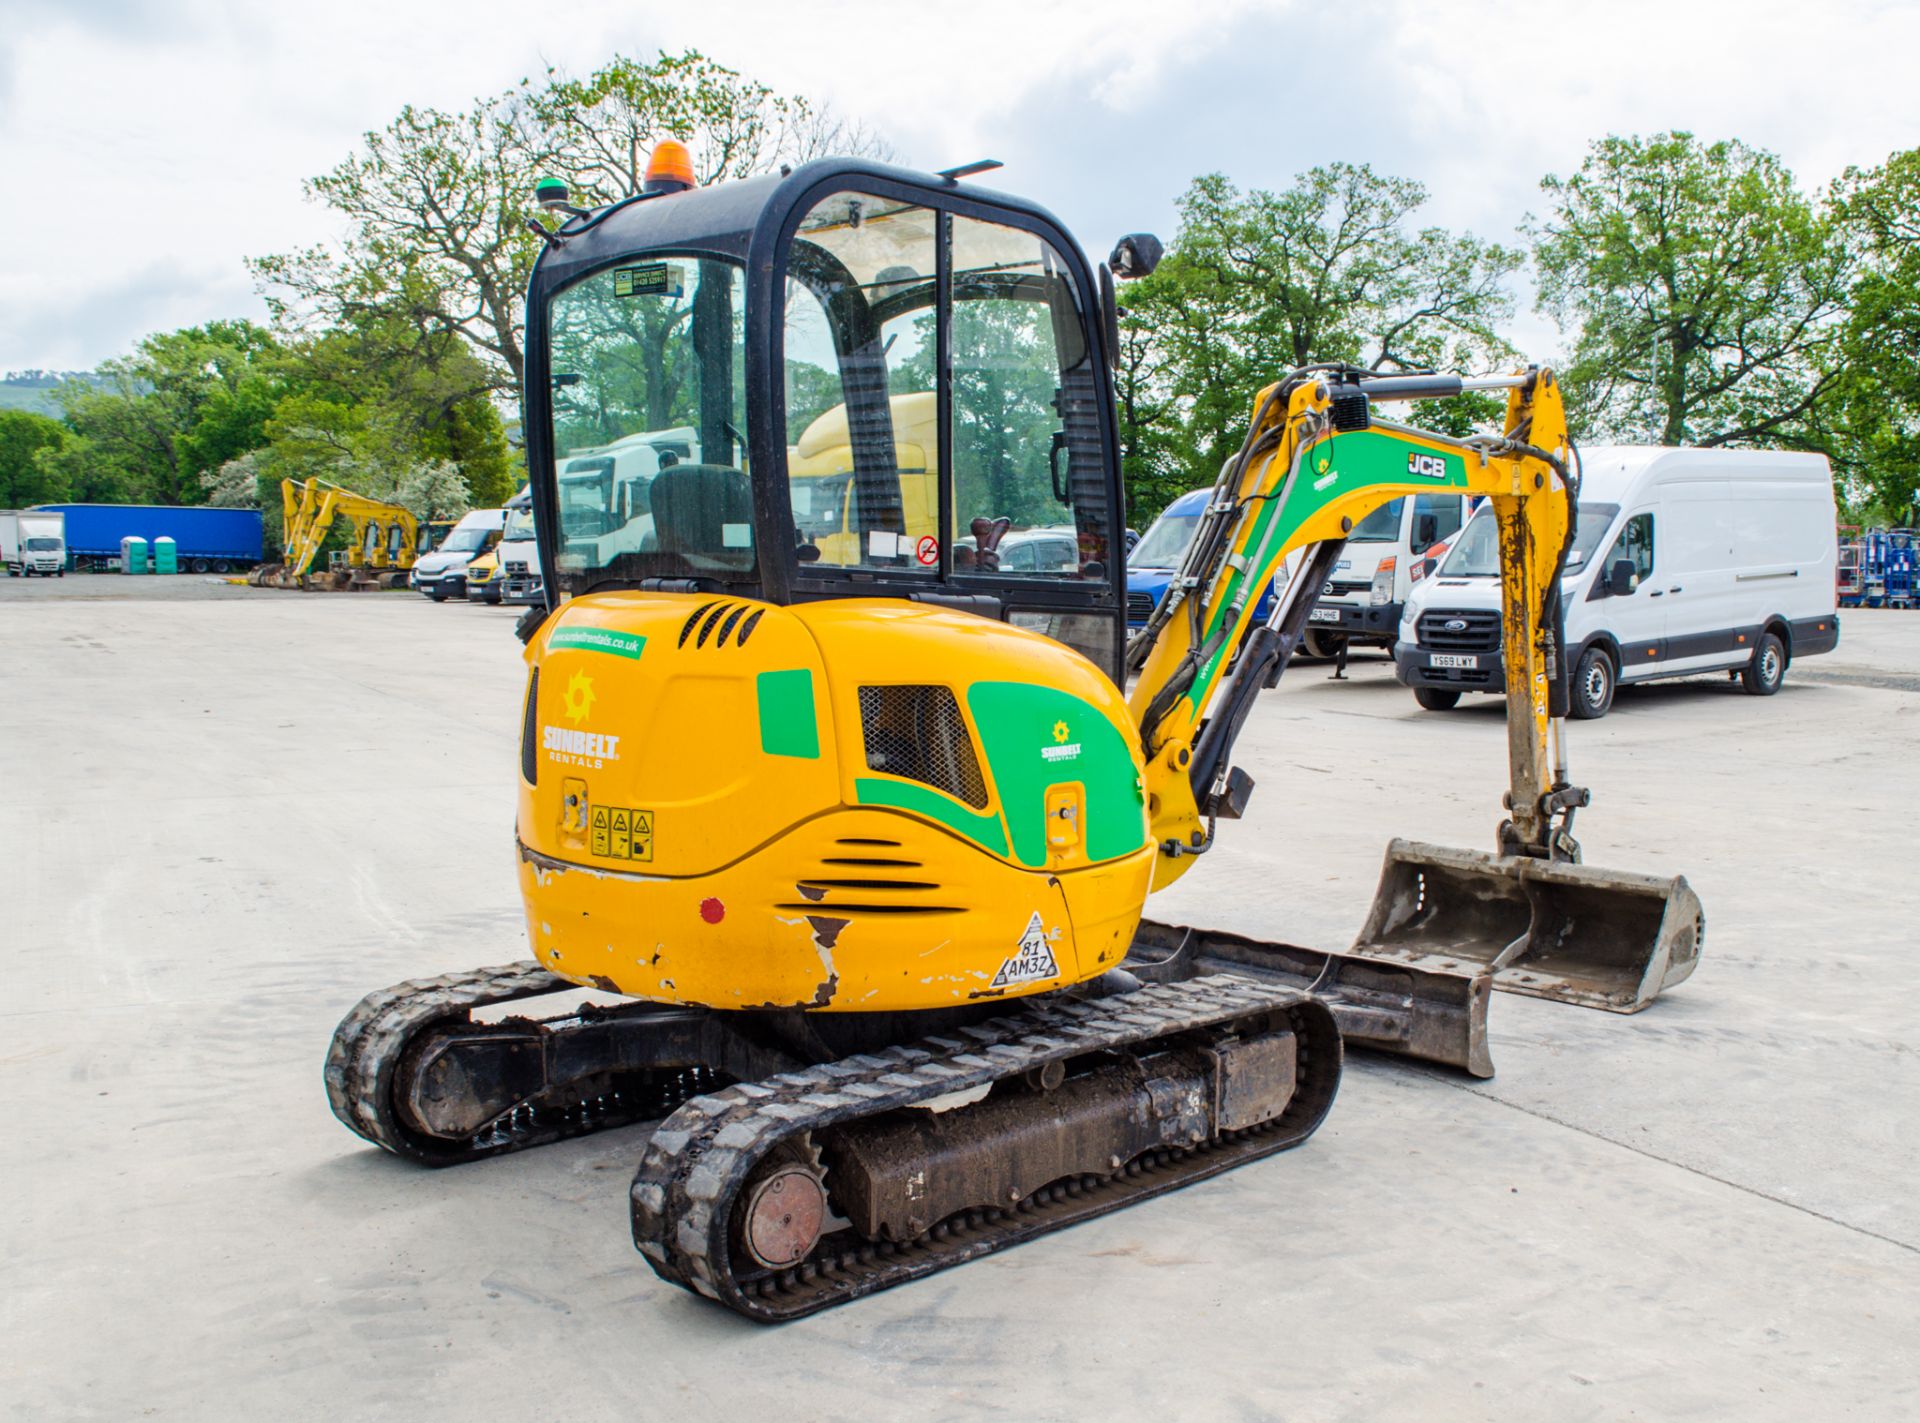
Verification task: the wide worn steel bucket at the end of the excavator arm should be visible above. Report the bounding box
[1354,839,1705,1012]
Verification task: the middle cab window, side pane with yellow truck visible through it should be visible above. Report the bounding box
[783,192,941,578]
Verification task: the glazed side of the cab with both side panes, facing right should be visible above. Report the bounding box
[781,179,1125,682]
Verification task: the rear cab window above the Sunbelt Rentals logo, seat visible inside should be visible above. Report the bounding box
[547,255,756,584]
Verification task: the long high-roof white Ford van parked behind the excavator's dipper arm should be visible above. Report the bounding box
[1394,446,1839,718]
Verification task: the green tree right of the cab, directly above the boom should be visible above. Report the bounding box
[1117,163,1523,507]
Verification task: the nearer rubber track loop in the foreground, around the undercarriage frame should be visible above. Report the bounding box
[632,974,1340,1323]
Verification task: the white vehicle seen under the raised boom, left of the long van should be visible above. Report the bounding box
[1304,494,1469,657]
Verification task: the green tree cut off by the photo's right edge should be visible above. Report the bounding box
[1830,148,1920,524]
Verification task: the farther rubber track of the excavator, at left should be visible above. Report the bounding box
[326,960,701,1166]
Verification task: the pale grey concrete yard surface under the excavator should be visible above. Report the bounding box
[0,576,1920,1423]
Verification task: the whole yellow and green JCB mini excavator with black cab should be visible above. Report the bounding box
[326,154,1701,1321]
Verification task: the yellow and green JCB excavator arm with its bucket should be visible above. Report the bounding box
[1127,367,1703,1012]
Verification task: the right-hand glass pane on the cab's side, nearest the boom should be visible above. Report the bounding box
[950,217,1112,582]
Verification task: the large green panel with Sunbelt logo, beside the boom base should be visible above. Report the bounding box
[966,682,1146,868]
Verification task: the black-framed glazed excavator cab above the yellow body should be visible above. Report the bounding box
[526,161,1125,686]
